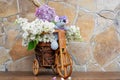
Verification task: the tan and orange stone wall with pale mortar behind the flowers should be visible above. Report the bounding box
[0,0,120,72]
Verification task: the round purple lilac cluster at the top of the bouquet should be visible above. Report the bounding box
[35,5,56,21]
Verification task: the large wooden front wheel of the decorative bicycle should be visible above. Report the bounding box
[57,52,72,79]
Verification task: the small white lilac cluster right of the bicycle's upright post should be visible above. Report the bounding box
[66,26,82,42]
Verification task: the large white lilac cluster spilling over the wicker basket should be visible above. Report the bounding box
[17,18,55,46]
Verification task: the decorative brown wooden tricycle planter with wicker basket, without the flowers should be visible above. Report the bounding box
[33,30,72,79]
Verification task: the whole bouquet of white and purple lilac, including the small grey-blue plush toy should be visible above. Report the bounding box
[16,5,82,50]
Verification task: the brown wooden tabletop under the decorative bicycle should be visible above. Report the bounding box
[0,72,120,80]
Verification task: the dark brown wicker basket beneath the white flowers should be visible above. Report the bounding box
[35,42,55,66]
